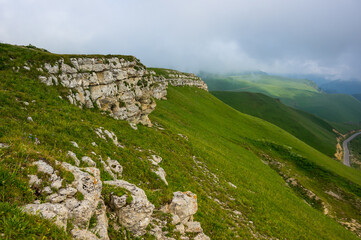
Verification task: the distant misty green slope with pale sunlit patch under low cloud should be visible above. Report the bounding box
[203,75,361,123]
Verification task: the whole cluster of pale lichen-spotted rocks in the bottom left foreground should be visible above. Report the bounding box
[22,158,209,240]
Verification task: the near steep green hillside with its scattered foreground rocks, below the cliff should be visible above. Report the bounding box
[0,45,361,240]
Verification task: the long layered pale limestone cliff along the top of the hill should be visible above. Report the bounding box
[33,56,208,126]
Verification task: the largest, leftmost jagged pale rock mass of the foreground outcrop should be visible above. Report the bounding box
[23,160,109,240]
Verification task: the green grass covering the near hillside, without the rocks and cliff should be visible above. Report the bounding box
[0,44,361,239]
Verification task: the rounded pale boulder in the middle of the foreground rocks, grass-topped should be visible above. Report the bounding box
[104,180,154,236]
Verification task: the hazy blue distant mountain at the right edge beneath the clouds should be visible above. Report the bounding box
[321,79,361,95]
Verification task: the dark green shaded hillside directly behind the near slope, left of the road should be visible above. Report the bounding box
[212,91,336,157]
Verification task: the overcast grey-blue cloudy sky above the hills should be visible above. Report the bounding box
[0,0,361,80]
